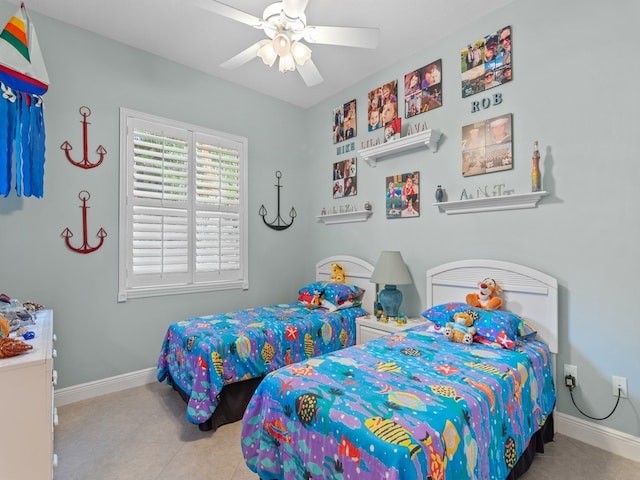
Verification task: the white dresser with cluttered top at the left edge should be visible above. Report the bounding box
[0,310,58,480]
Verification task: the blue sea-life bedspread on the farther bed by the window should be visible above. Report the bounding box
[157,303,366,424]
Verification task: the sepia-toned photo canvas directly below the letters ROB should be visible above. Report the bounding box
[462,113,513,177]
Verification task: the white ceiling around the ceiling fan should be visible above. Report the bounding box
[15,0,513,108]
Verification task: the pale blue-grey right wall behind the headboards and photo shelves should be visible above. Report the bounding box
[307,0,640,436]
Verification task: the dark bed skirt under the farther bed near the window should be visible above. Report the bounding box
[166,375,264,432]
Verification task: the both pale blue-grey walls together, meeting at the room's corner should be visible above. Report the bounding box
[0,0,640,436]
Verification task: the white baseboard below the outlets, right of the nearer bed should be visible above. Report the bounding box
[555,412,640,462]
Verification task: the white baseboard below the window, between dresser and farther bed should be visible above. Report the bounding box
[54,367,158,407]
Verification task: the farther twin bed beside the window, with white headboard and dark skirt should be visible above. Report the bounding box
[157,255,375,430]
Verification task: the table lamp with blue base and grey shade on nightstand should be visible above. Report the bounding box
[370,251,413,318]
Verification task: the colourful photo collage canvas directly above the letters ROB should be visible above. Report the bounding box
[460,26,513,98]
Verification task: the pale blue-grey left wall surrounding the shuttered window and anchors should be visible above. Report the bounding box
[0,2,308,387]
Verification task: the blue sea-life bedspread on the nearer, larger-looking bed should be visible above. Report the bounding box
[242,325,555,480]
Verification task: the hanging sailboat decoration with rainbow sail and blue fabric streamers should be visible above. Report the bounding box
[0,3,49,198]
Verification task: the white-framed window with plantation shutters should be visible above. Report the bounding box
[118,109,248,301]
